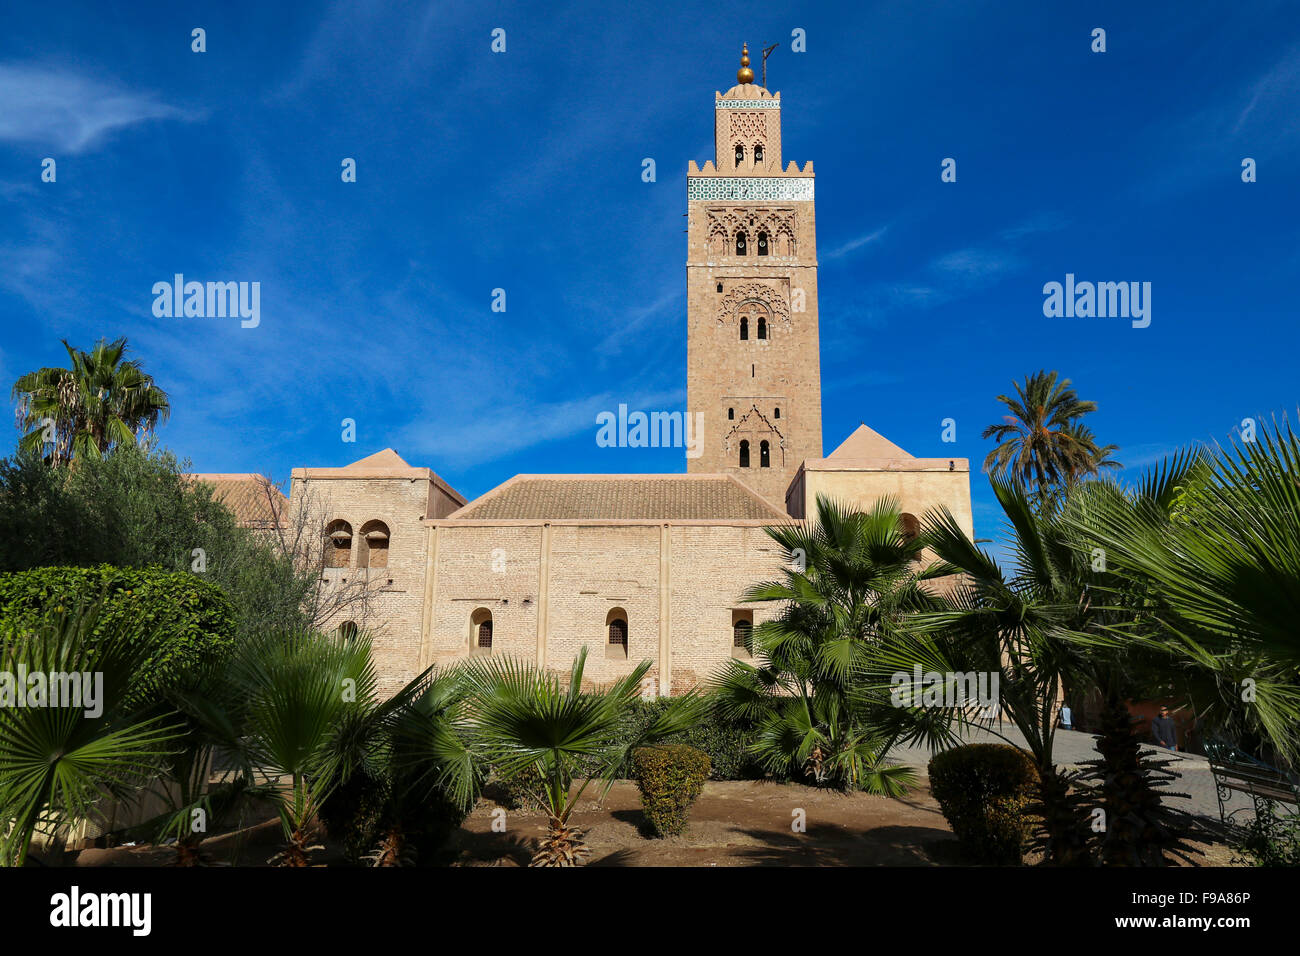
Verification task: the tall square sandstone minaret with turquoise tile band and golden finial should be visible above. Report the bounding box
[686,44,822,507]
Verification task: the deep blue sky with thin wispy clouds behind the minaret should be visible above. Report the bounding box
[0,0,1300,536]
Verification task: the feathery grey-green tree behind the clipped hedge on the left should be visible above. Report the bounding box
[0,446,316,642]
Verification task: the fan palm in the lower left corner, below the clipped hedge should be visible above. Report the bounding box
[0,607,176,866]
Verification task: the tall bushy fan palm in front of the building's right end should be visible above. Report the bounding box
[712,496,951,793]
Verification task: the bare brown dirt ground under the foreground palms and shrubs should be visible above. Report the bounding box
[55,780,1232,866]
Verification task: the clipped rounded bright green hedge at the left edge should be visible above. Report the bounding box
[0,564,235,701]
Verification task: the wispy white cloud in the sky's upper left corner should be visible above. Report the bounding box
[0,64,187,153]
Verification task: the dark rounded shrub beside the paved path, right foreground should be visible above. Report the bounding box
[930,744,1039,864]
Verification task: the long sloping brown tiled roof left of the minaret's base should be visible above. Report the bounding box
[451,475,789,522]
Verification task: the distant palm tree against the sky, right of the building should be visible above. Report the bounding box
[980,371,1119,499]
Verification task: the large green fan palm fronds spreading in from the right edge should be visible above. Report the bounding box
[1070,425,1300,762]
